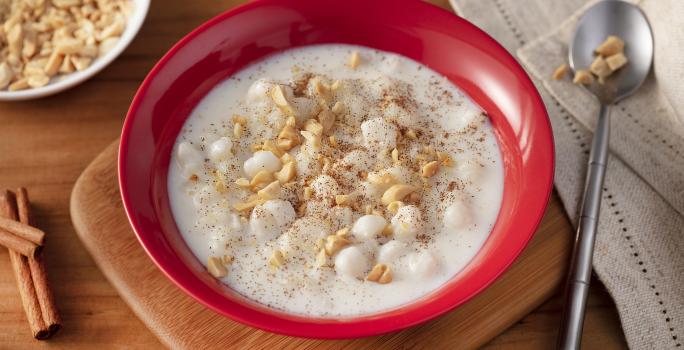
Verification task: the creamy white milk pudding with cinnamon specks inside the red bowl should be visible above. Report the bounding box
[168,44,503,317]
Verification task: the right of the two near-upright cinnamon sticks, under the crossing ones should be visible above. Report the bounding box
[16,187,62,336]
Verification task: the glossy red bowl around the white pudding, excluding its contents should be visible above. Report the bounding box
[119,0,554,338]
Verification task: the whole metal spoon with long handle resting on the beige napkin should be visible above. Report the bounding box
[558,0,653,349]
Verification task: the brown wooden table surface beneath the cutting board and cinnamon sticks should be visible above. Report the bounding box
[0,0,626,350]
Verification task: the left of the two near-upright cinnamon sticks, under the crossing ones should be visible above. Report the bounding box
[0,191,50,339]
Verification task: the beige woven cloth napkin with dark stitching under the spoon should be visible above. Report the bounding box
[451,0,684,349]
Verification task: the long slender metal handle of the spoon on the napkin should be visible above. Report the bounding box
[558,104,610,350]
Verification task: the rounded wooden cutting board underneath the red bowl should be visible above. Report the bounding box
[71,141,572,349]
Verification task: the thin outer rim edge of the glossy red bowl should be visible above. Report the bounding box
[118,0,555,339]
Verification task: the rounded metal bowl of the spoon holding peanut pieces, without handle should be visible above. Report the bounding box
[569,0,654,104]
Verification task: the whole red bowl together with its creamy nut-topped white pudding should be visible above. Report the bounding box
[119,0,553,337]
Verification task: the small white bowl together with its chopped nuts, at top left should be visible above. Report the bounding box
[0,0,150,101]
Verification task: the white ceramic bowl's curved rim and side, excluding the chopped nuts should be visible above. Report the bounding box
[0,0,150,101]
